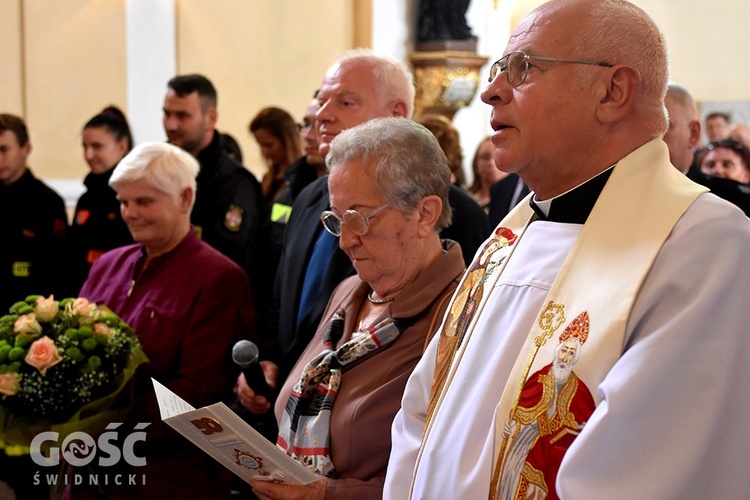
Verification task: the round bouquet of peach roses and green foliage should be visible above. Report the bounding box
[0,295,148,452]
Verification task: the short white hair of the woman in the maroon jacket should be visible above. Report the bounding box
[109,142,200,208]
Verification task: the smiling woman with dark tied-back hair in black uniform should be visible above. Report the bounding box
[70,106,133,290]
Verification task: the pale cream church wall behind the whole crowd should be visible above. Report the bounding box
[0,0,750,206]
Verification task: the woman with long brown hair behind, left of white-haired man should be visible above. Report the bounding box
[249,107,302,208]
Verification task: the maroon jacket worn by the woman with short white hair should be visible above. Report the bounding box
[80,231,257,498]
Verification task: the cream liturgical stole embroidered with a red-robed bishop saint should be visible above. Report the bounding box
[415,139,706,499]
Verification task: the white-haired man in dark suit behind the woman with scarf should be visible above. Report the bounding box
[238,50,490,413]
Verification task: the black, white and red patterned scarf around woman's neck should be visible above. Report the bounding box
[276,309,411,476]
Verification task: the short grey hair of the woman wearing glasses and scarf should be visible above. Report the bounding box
[326,117,452,231]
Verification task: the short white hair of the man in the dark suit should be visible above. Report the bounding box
[335,49,415,118]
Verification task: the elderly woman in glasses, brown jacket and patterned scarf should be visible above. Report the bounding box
[244,118,464,500]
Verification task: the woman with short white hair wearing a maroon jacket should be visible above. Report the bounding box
[80,143,254,498]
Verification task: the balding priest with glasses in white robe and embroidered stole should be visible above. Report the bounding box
[384,0,750,499]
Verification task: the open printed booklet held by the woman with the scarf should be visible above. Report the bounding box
[151,378,318,484]
